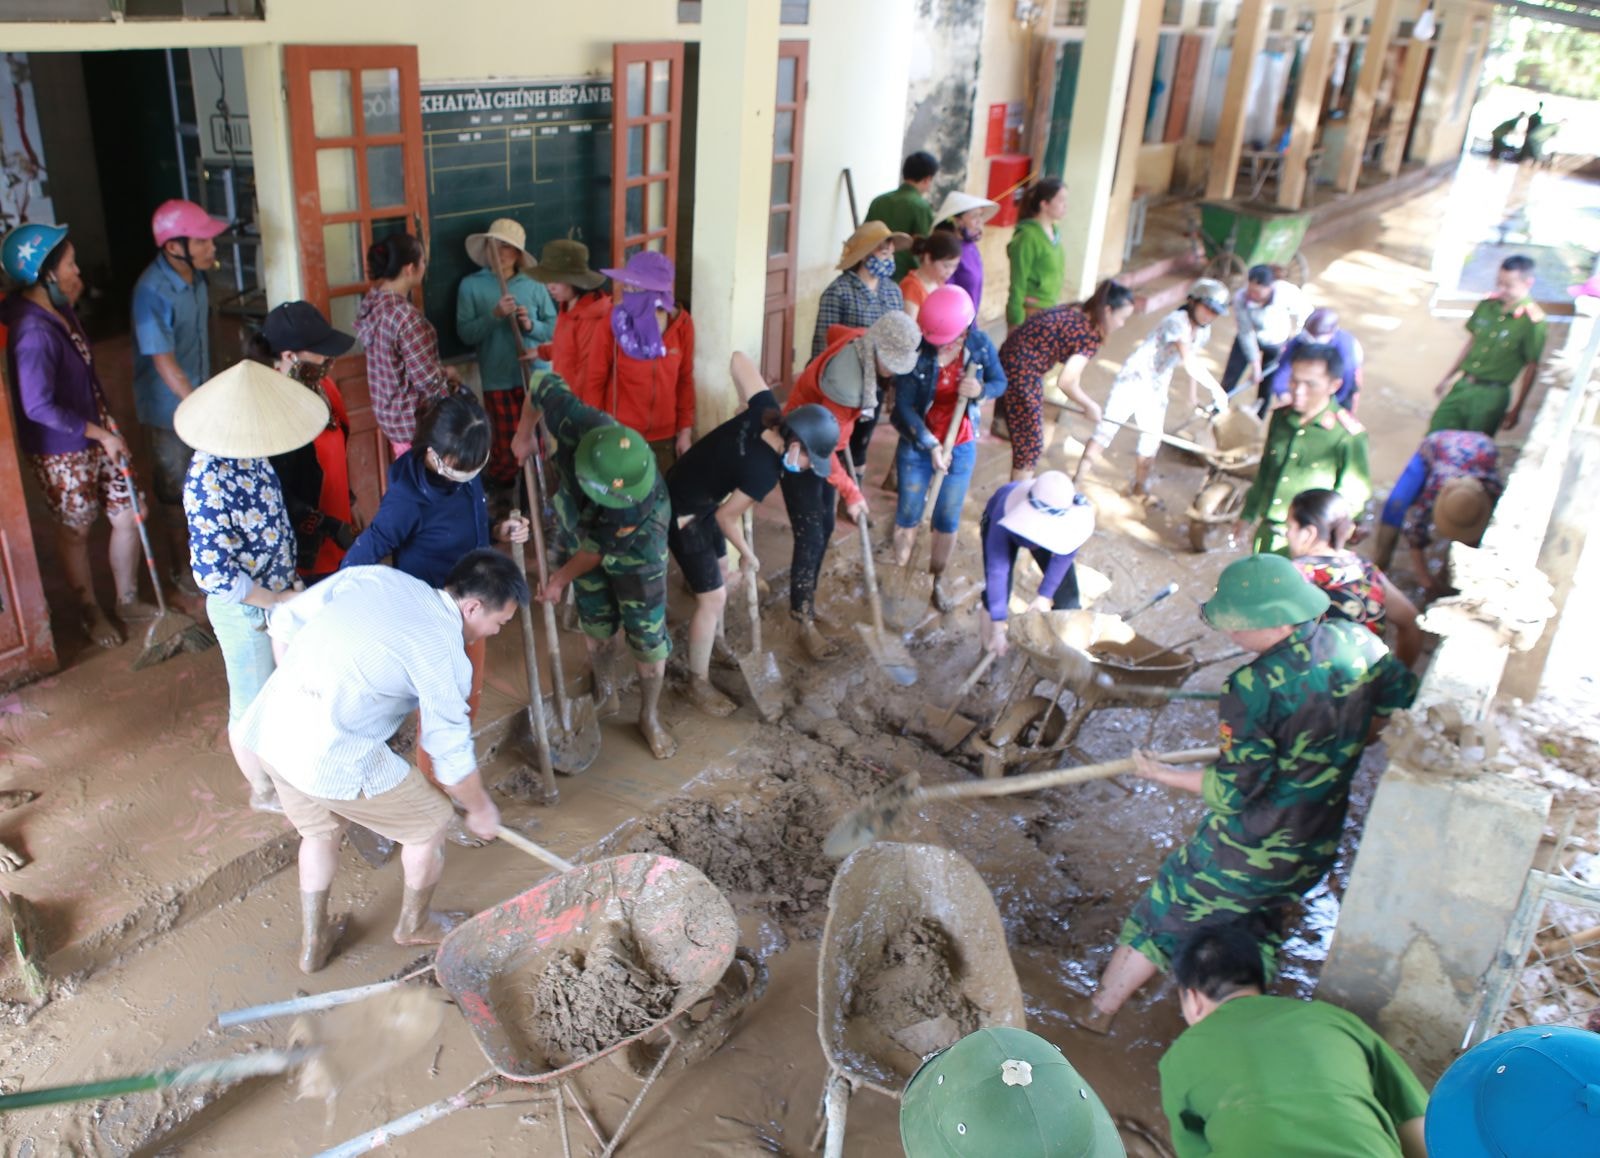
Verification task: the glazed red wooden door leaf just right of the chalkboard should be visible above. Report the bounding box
[611,40,683,267]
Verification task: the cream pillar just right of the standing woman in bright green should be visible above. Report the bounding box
[1061,3,1155,301]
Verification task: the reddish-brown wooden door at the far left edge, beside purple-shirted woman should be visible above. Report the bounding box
[0,361,61,689]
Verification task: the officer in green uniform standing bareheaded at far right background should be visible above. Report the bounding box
[1427,253,1547,438]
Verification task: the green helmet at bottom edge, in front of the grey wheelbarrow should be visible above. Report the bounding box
[901,1025,1126,1158]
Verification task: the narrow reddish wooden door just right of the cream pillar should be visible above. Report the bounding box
[762,40,810,390]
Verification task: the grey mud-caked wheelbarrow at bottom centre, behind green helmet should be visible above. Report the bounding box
[811,841,1027,1158]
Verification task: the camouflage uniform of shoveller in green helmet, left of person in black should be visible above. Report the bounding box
[528,371,672,664]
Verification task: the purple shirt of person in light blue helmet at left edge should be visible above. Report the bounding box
[0,294,101,454]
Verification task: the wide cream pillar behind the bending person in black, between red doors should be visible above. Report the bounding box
[693,3,779,433]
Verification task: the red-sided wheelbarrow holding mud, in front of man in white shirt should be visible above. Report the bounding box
[224,853,766,1156]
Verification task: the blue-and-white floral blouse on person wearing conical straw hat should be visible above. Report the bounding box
[184,451,294,603]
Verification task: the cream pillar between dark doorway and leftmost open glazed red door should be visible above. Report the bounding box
[243,45,306,304]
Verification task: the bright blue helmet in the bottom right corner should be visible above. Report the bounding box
[1426,1025,1600,1158]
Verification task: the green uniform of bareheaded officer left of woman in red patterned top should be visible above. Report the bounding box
[1238,400,1373,555]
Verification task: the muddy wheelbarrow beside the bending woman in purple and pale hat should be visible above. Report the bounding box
[968,611,1198,779]
